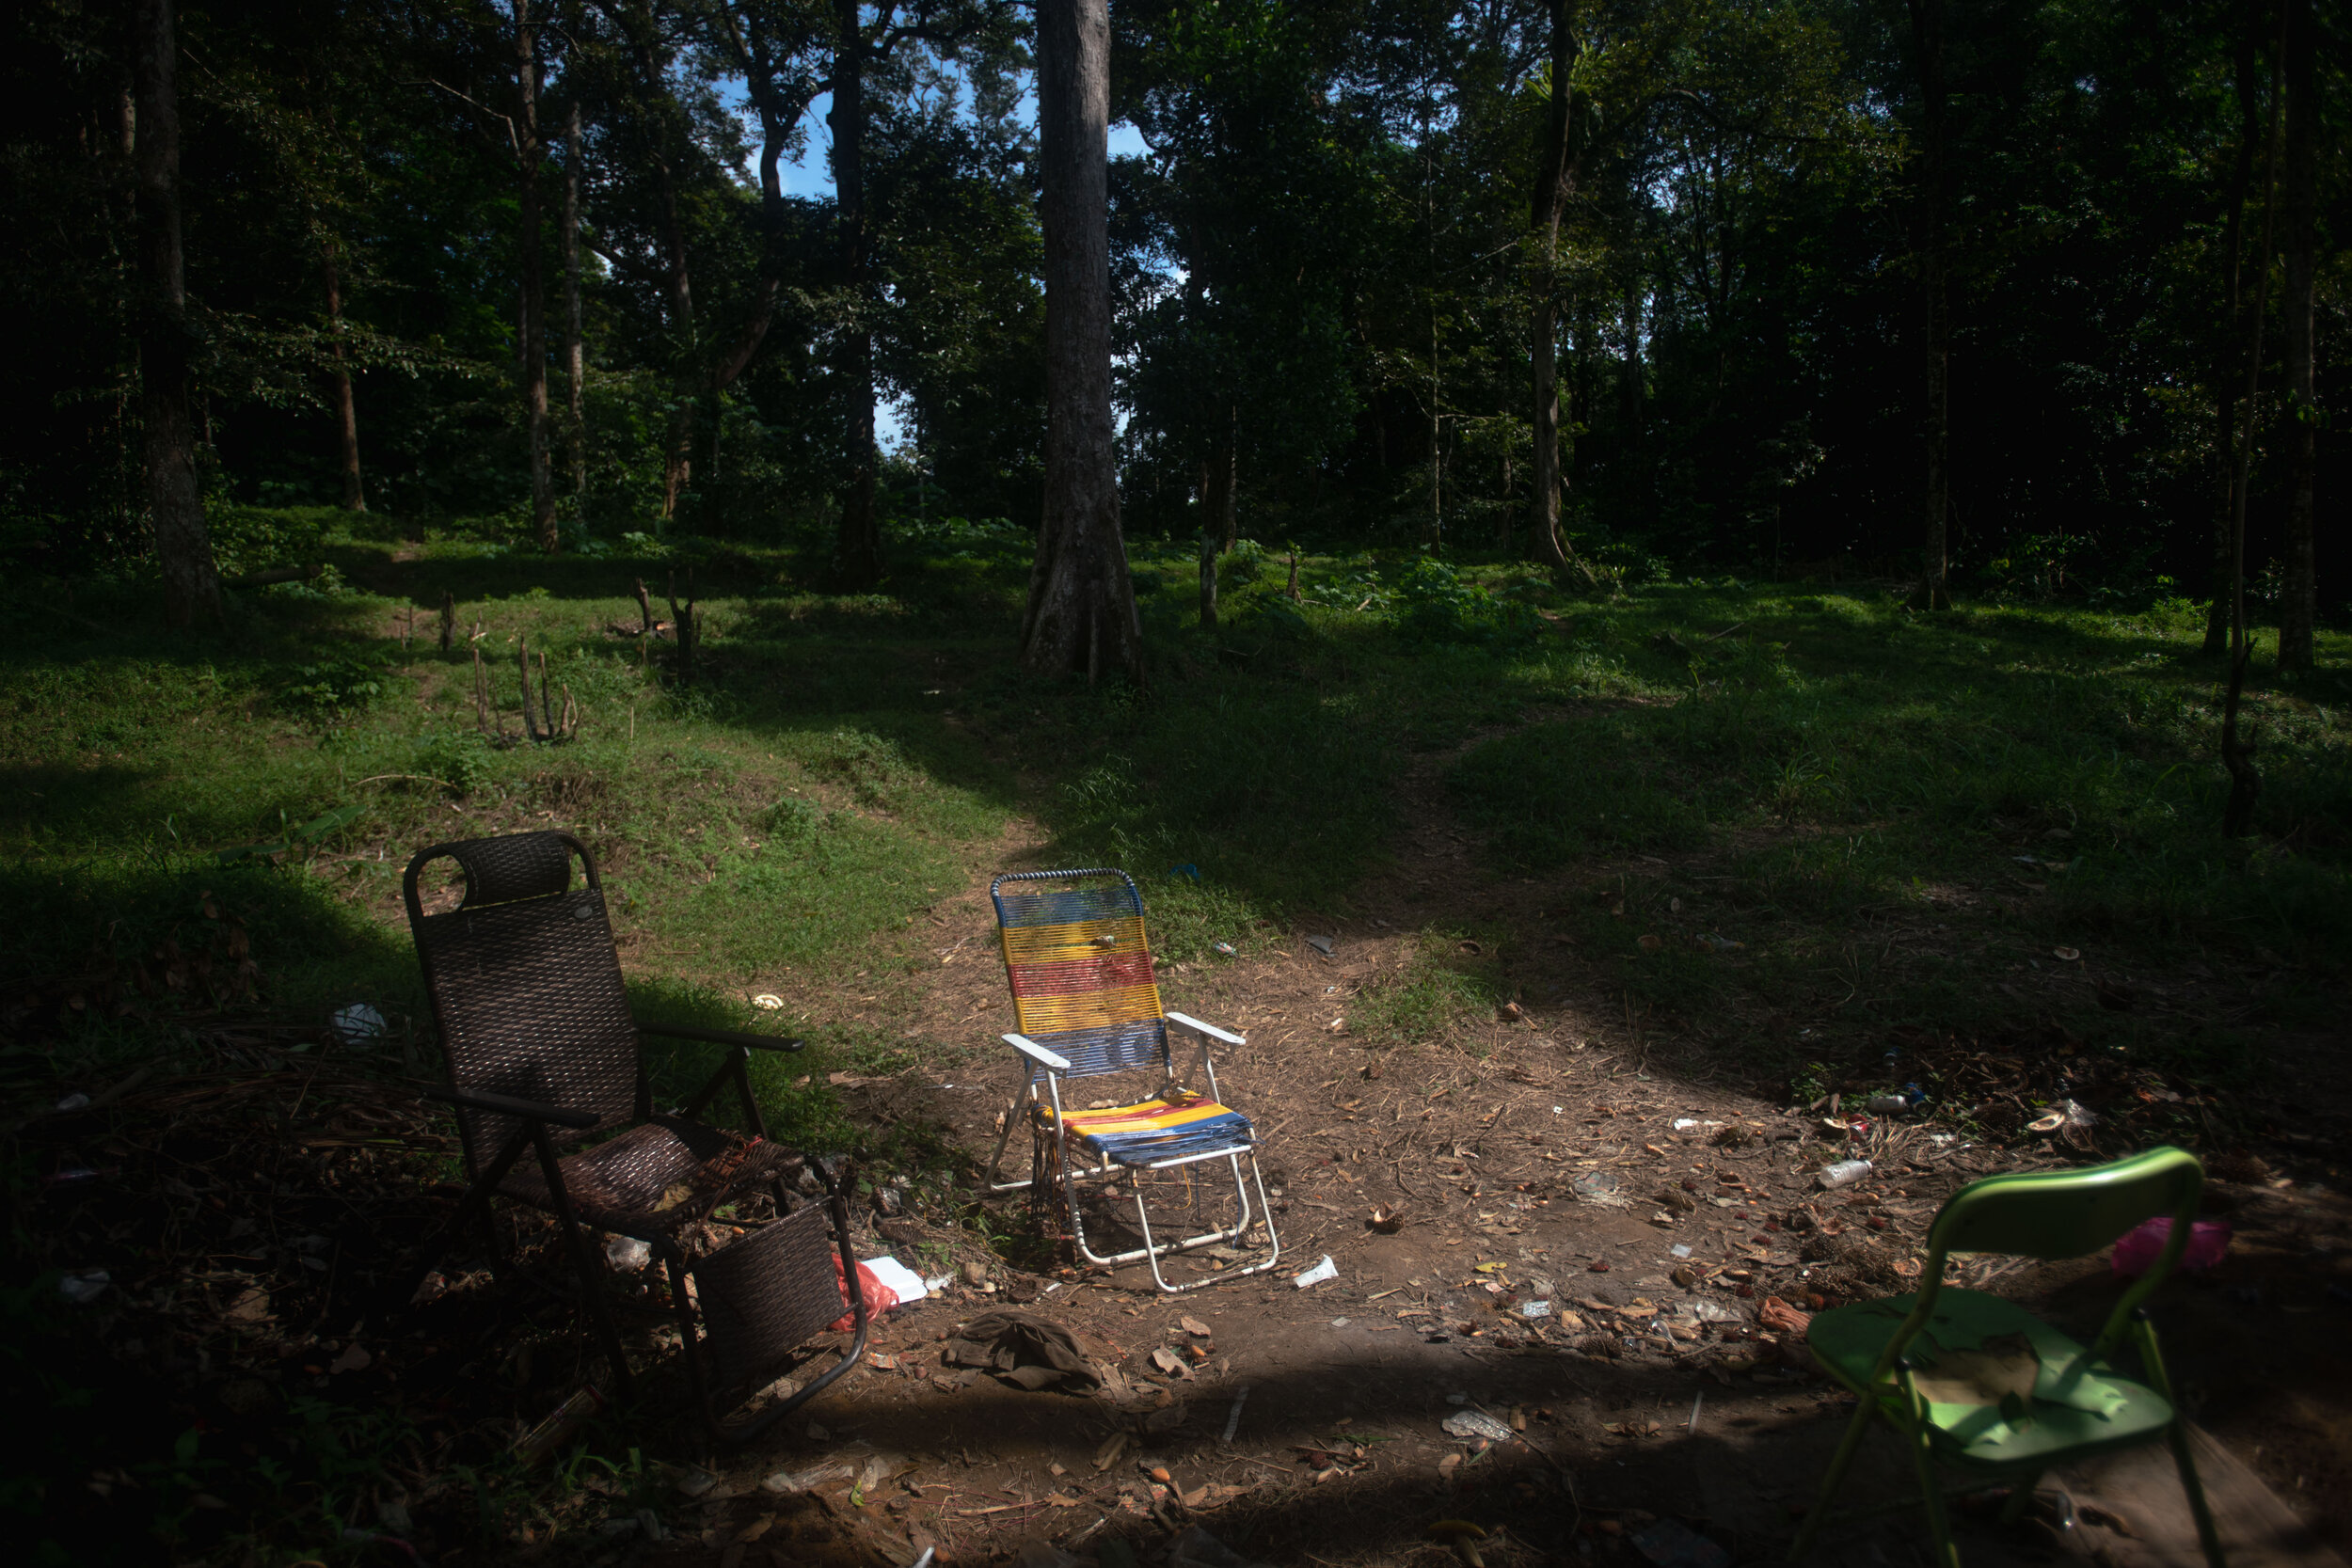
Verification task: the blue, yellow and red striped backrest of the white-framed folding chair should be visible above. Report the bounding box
[988,870,1169,1082]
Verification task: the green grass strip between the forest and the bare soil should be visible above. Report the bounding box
[0,513,2352,1117]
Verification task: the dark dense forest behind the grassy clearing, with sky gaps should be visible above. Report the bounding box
[0,0,2352,618]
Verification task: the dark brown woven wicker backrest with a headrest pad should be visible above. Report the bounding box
[403,832,644,1173]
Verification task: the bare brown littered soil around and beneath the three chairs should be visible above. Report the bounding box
[23,737,2352,1568]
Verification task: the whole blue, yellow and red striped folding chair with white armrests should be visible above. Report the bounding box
[988,870,1282,1293]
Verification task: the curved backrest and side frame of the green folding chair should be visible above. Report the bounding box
[1872,1148,2204,1387]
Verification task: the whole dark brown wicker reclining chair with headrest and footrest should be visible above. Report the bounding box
[403,832,868,1441]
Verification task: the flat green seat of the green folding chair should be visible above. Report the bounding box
[1806,1289,2173,1472]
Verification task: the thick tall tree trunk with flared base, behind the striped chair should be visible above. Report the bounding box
[1021,0,1143,684]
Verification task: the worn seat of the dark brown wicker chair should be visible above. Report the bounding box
[499,1117,790,1242]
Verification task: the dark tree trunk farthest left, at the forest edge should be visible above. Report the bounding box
[132,0,221,630]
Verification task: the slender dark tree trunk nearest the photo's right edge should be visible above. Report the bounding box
[2280,0,2319,670]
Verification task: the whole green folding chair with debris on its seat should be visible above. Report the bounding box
[1788,1149,2225,1568]
